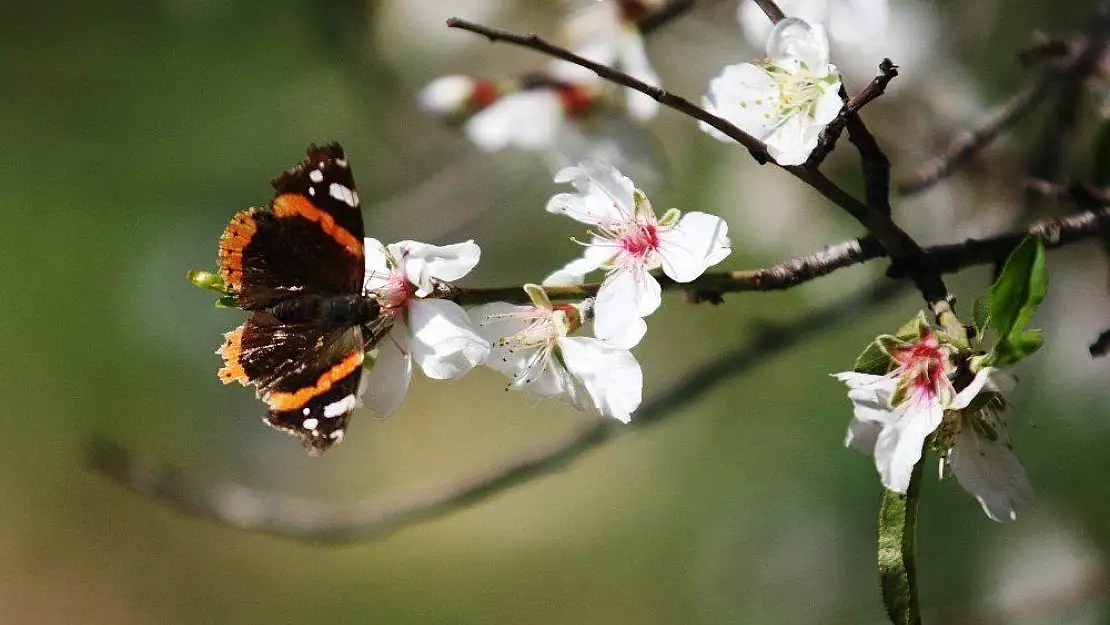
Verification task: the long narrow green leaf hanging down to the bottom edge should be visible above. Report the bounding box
[878,457,925,625]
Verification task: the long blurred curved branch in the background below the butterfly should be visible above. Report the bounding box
[88,282,904,543]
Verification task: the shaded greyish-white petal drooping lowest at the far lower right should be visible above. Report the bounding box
[948,425,1033,523]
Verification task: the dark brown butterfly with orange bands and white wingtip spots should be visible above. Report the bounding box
[216,143,390,454]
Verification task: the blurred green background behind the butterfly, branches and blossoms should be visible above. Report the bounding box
[0,0,1110,625]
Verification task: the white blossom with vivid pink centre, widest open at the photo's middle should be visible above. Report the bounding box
[544,161,731,347]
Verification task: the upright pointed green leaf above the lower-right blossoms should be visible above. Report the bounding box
[988,236,1048,342]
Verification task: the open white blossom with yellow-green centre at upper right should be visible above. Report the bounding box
[700,18,844,165]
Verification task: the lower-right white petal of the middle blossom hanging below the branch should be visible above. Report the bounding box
[558,336,644,423]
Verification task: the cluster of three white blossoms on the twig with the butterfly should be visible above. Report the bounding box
[223,162,729,422]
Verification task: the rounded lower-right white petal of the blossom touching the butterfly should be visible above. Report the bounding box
[408,300,490,380]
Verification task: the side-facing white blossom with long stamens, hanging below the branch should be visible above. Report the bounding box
[470,284,644,423]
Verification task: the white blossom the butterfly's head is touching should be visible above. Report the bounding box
[363,239,490,417]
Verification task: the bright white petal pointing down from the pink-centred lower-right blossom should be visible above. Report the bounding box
[875,395,945,493]
